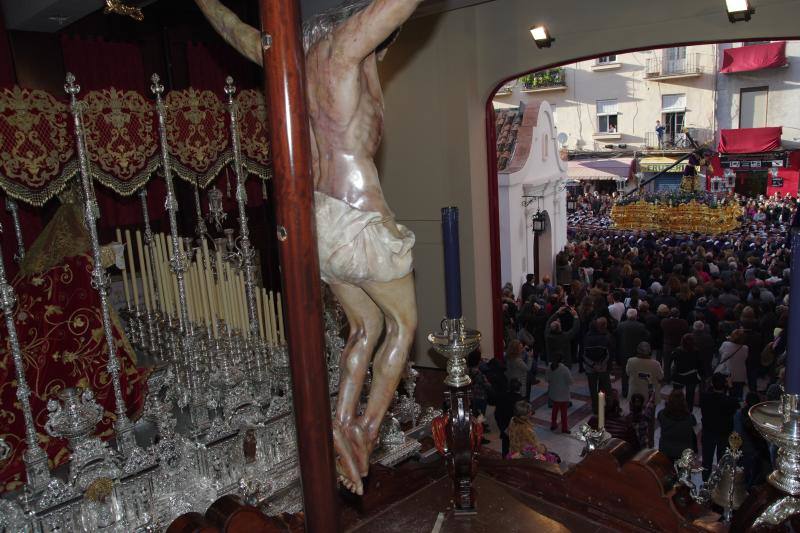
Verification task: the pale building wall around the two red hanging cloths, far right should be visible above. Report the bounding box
[717,41,800,148]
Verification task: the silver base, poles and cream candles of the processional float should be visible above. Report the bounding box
[0,65,438,531]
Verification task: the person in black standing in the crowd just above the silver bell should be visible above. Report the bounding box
[700,373,739,481]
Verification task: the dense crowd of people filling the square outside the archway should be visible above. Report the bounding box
[482,189,796,486]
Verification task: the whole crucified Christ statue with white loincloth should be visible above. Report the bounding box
[195,0,420,494]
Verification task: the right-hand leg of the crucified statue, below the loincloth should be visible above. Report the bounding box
[353,273,417,468]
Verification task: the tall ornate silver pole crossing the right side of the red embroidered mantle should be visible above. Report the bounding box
[64,72,136,455]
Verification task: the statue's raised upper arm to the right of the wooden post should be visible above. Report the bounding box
[331,0,421,65]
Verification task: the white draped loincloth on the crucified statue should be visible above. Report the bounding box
[314,192,415,285]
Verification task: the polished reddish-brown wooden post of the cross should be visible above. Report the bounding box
[260,0,339,533]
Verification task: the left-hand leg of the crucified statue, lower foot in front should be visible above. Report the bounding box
[330,283,383,494]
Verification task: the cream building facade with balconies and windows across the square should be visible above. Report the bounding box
[494,44,718,151]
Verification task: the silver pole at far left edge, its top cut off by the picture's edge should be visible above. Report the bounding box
[0,219,50,492]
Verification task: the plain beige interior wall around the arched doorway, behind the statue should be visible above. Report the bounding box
[379,0,800,364]
